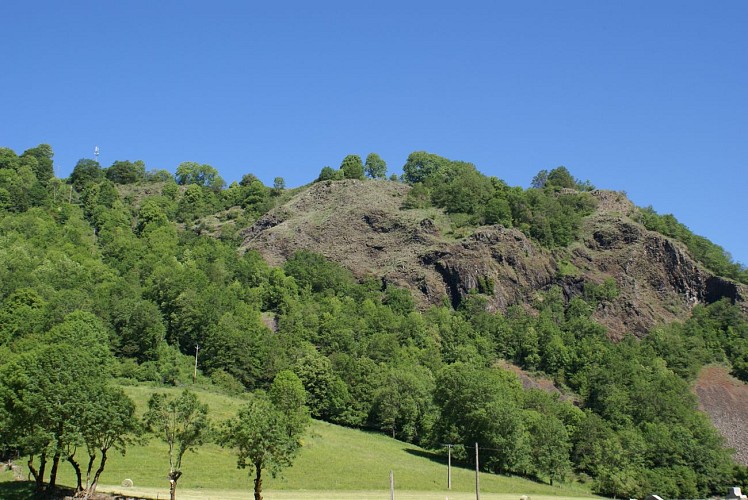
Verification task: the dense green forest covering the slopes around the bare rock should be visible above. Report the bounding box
[0,145,748,498]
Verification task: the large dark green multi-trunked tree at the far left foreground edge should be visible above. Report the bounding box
[0,328,114,491]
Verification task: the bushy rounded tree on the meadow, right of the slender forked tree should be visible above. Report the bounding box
[221,372,309,500]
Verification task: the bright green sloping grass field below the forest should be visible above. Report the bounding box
[0,386,591,500]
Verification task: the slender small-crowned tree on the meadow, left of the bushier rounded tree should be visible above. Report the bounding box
[143,389,208,500]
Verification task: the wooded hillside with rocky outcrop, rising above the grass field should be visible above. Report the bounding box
[0,147,748,498]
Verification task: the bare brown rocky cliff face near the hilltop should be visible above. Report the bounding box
[242,181,748,338]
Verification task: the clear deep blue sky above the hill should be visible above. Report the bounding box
[0,0,748,263]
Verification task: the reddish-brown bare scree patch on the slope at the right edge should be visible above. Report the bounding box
[693,366,748,465]
